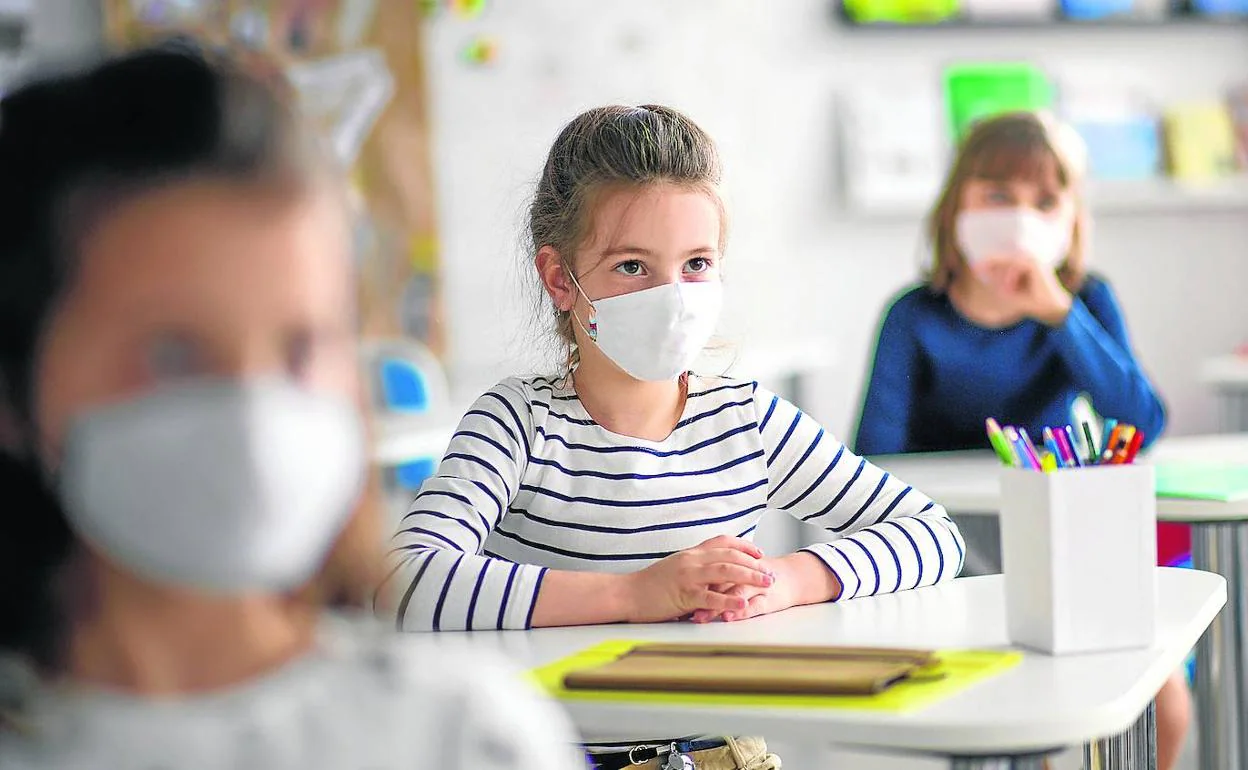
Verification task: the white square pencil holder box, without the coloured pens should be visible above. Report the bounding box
[1001,465,1157,655]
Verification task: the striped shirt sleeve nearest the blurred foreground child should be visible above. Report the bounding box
[381,381,545,631]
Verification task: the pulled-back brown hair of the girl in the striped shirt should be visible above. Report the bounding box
[525,105,728,364]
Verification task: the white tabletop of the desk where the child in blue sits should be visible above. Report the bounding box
[871,433,1248,522]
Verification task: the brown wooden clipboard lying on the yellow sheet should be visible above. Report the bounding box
[564,644,936,695]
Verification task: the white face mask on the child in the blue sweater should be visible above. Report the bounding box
[956,208,1073,270]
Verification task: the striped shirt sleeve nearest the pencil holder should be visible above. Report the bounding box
[755,387,965,599]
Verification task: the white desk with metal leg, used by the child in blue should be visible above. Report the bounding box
[872,433,1248,770]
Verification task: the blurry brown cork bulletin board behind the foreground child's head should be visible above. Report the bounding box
[101,0,446,357]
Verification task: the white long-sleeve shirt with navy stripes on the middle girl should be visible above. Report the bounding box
[383,377,963,630]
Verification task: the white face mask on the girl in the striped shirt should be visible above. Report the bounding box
[573,278,724,382]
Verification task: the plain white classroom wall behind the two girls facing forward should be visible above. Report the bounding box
[429,0,1248,434]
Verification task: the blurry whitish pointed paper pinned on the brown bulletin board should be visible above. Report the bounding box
[287,49,394,167]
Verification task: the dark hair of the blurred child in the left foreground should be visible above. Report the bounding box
[0,42,381,673]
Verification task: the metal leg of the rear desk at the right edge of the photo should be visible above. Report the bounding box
[1192,523,1248,770]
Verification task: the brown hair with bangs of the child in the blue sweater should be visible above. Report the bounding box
[927,112,1088,293]
